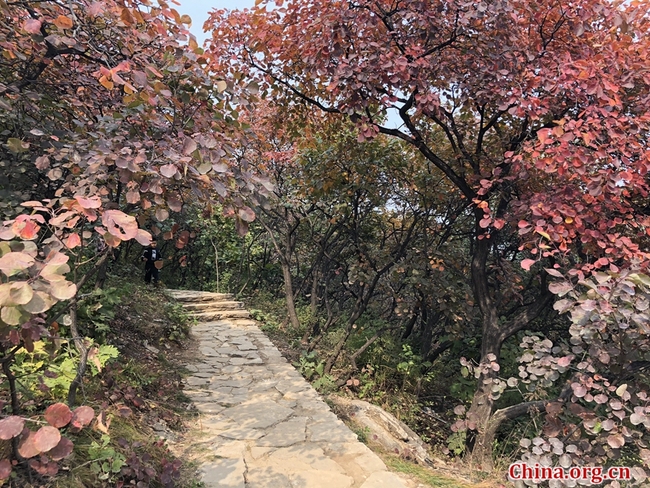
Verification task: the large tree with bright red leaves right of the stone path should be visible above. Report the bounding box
[206,0,650,462]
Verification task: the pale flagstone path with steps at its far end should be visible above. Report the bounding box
[169,290,407,488]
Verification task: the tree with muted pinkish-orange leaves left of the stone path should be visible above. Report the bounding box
[0,0,263,479]
